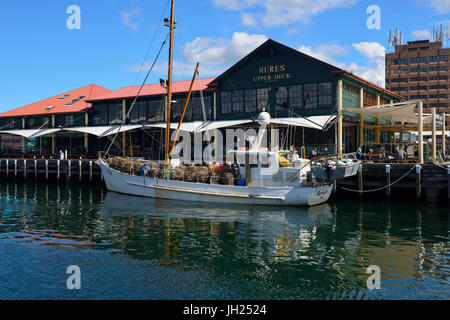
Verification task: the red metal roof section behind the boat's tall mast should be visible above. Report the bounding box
[87,78,215,102]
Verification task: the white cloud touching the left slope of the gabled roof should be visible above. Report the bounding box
[126,32,268,77]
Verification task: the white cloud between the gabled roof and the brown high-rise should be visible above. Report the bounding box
[298,42,386,86]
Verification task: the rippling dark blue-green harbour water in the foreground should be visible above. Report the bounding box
[0,181,450,299]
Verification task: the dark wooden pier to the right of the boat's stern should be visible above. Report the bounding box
[336,163,450,201]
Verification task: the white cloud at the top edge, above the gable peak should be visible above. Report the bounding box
[213,0,356,27]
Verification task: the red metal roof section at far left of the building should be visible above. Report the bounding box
[0,84,111,117]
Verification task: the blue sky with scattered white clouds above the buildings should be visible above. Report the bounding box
[0,0,450,112]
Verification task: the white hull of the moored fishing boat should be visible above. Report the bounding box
[98,159,332,206]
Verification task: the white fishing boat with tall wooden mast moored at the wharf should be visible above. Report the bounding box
[98,0,332,206]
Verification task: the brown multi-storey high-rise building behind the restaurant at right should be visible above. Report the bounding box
[386,40,450,113]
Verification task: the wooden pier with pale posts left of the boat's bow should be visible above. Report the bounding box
[0,159,103,184]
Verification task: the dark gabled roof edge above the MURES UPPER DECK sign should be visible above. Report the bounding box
[209,39,402,99]
